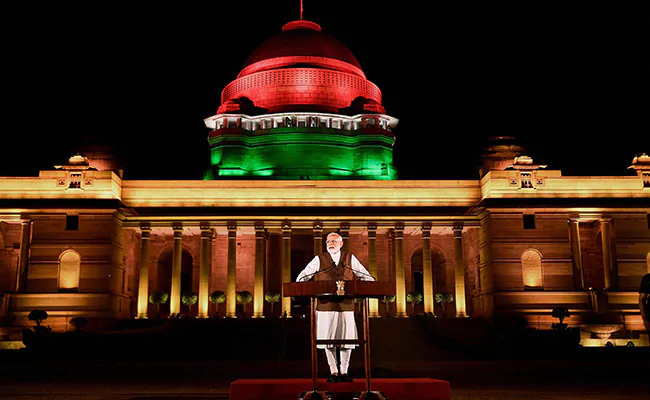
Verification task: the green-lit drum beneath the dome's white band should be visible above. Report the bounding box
[205,128,396,180]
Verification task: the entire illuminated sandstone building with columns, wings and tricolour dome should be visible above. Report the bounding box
[0,20,650,345]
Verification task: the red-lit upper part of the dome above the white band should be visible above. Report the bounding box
[217,20,385,114]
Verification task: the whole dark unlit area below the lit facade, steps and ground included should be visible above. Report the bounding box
[0,320,650,400]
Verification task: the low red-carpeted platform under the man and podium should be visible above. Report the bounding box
[230,378,451,400]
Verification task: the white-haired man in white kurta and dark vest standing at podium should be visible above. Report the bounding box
[296,232,375,382]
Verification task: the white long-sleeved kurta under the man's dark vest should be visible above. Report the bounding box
[296,251,375,349]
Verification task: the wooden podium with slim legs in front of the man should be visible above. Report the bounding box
[282,280,395,400]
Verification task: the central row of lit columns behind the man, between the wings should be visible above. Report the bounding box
[137,221,467,318]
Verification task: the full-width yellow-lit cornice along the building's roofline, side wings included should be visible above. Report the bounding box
[0,170,650,209]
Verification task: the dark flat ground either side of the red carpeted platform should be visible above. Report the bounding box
[0,354,650,400]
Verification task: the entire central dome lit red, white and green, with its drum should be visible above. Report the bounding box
[204,19,398,180]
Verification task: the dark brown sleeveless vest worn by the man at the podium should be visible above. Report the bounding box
[314,251,358,311]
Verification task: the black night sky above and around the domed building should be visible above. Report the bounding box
[0,0,650,179]
